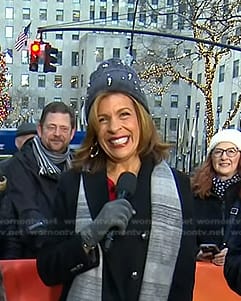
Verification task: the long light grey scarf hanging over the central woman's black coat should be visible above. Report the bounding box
[67,161,182,301]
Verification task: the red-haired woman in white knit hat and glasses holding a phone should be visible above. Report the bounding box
[192,129,241,265]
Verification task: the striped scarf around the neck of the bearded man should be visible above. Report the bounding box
[33,136,71,179]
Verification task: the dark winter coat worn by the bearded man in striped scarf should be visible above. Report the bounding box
[0,141,62,259]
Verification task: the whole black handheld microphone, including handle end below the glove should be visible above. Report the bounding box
[105,172,137,251]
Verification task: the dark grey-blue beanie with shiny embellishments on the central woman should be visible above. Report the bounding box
[85,58,149,120]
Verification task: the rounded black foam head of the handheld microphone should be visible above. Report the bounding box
[116,172,137,198]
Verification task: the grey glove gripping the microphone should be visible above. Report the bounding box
[80,199,135,248]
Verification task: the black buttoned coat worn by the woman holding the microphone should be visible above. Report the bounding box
[37,157,197,301]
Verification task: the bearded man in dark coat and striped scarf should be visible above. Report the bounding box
[0,102,75,259]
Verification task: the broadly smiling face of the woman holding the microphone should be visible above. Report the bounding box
[97,93,140,162]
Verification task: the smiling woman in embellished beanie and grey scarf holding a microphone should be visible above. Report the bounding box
[37,59,197,301]
